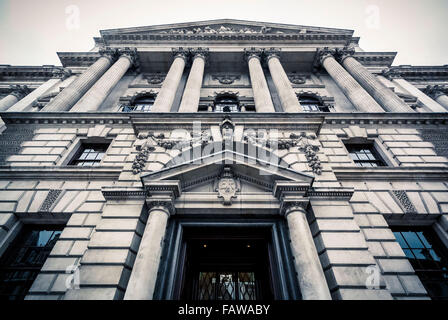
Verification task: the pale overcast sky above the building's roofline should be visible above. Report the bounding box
[0,0,448,65]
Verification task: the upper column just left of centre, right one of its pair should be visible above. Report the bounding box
[179,49,207,112]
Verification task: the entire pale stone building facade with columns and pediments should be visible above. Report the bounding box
[0,20,448,300]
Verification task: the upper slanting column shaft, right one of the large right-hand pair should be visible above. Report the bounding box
[342,56,414,112]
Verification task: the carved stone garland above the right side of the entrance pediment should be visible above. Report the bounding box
[244,131,322,175]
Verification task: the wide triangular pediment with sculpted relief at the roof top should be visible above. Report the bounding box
[101,19,353,36]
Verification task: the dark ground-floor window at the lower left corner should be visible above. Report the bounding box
[0,226,62,300]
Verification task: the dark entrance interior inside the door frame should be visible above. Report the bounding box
[178,228,274,300]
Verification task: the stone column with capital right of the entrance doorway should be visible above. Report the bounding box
[282,201,331,300]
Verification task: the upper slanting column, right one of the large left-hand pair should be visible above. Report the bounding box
[70,50,136,112]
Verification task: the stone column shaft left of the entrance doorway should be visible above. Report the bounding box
[124,206,170,300]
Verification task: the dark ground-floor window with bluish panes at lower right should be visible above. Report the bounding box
[393,228,448,300]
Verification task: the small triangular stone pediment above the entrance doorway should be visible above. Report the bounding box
[141,150,314,191]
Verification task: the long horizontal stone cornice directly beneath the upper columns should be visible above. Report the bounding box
[0,112,448,129]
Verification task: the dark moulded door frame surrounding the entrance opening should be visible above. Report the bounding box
[153,215,301,300]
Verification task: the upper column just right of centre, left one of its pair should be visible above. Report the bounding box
[245,50,275,112]
